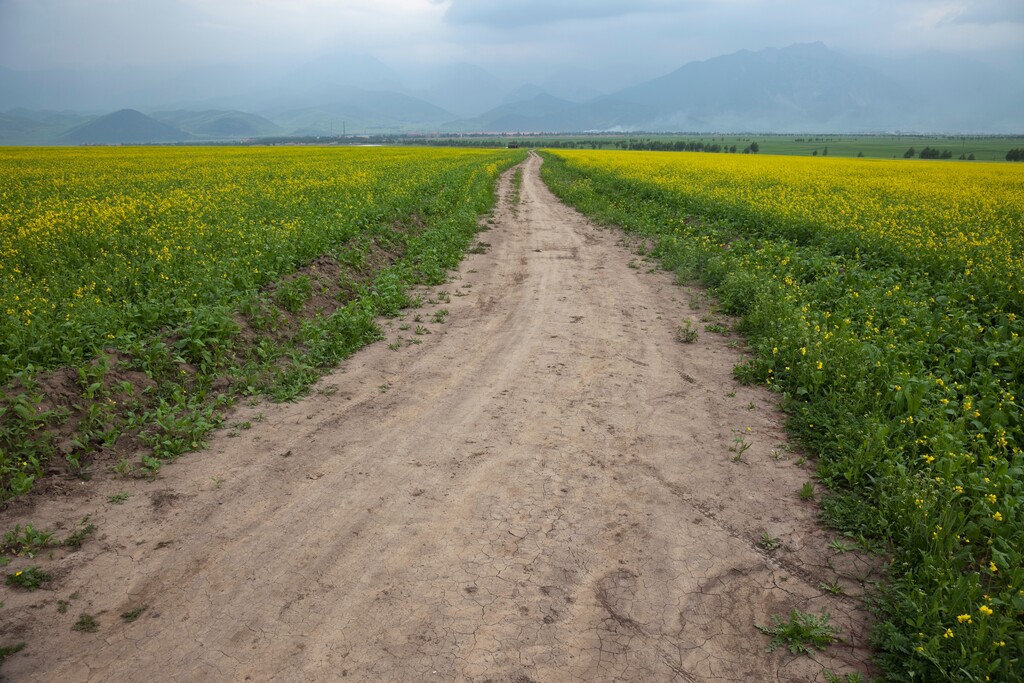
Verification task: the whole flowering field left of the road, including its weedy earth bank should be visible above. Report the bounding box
[0,147,523,500]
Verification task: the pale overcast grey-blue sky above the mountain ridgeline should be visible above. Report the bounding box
[0,0,1024,82]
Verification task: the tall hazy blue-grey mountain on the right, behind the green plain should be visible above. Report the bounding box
[452,43,1024,132]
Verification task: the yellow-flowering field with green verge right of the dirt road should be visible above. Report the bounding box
[543,151,1024,681]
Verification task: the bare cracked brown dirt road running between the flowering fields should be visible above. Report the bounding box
[2,156,866,683]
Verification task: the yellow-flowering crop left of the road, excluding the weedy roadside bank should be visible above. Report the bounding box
[0,147,508,381]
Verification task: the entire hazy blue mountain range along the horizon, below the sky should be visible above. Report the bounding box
[0,43,1024,144]
